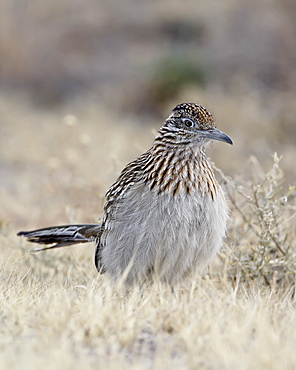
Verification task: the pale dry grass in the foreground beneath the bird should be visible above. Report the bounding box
[0,252,296,369]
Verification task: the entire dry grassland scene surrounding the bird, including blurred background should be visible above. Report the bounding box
[0,0,296,370]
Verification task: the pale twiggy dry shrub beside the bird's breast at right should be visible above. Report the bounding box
[216,153,296,289]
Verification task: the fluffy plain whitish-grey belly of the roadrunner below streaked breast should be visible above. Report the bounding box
[101,184,227,283]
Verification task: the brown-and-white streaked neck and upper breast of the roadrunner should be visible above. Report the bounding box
[144,141,219,199]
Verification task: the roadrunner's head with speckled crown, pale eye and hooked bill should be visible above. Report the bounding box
[163,103,232,147]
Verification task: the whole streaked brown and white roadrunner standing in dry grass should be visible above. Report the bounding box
[17,102,233,285]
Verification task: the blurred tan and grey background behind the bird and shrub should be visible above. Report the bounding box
[0,0,296,232]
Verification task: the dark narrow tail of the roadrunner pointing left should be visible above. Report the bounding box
[17,224,101,252]
